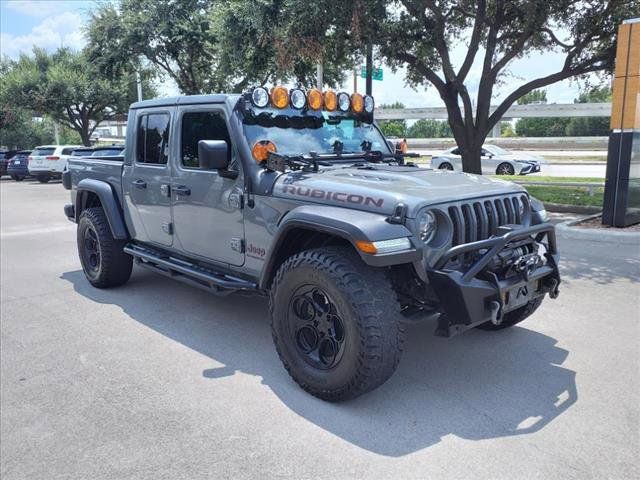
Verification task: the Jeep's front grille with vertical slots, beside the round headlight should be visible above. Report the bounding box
[448,194,530,245]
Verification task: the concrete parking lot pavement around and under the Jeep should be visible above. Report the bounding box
[0,179,640,480]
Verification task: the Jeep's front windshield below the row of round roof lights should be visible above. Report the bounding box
[244,112,390,155]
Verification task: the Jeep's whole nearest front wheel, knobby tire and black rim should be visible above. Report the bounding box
[270,247,404,401]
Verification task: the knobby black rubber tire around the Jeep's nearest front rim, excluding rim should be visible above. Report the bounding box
[269,247,404,402]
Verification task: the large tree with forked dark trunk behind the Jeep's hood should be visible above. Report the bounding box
[274,0,639,173]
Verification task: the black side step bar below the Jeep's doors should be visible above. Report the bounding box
[124,244,259,294]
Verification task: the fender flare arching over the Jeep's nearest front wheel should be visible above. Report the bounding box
[260,205,422,286]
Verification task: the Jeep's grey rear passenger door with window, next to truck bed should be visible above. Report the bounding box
[123,112,173,246]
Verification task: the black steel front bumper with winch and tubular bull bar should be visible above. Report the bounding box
[427,223,560,337]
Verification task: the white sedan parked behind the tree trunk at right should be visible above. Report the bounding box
[431,145,544,175]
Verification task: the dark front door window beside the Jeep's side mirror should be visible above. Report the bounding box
[180,112,231,168]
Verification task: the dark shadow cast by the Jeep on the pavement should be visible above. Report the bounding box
[62,269,577,457]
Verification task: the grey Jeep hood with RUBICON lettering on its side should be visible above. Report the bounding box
[273,165,524,217]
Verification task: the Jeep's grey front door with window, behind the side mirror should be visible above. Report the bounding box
[171,106,244,265]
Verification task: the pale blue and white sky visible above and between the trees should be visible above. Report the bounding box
[0,0,600,107]
